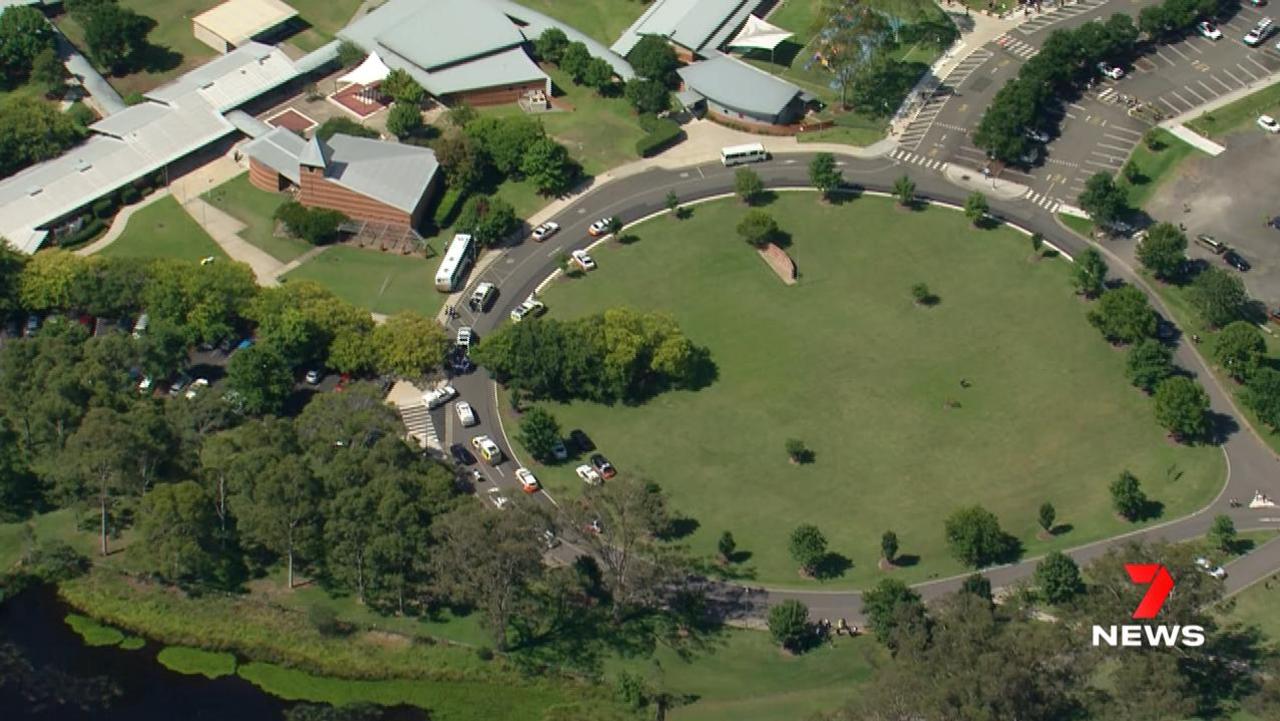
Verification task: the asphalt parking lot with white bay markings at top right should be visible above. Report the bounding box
[891,0,1280,211]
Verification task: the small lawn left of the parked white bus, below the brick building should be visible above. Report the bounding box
[284,246,445,316]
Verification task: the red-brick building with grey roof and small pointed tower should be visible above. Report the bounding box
[243,128,440,228]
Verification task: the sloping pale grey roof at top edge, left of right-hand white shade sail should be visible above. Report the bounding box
[612,0,760,56]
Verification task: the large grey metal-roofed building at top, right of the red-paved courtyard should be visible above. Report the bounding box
[338,0,550,96]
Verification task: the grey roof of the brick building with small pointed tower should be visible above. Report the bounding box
[243,128,439,213]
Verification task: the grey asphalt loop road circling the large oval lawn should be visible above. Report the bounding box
[436,154,1280,622]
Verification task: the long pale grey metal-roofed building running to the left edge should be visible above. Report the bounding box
[0,44,297,252]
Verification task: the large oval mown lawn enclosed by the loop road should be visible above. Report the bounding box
[504,193,1224,587]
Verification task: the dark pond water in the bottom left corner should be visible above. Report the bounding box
[0,589,287,721]
